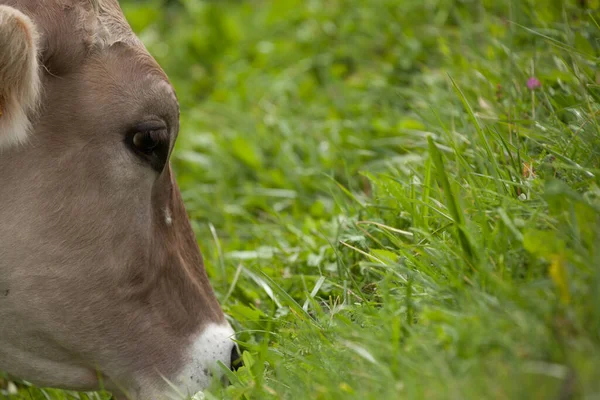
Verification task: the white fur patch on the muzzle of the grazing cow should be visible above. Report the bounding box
[174,323,235,395]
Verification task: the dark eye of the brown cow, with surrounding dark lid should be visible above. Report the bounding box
[125,122,170,172]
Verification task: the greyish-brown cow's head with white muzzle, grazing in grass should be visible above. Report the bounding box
[0,0,238,400]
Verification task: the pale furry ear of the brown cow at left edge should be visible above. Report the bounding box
[0,5,40,152]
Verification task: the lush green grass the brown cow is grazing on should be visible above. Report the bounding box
[0,0,600,400]
